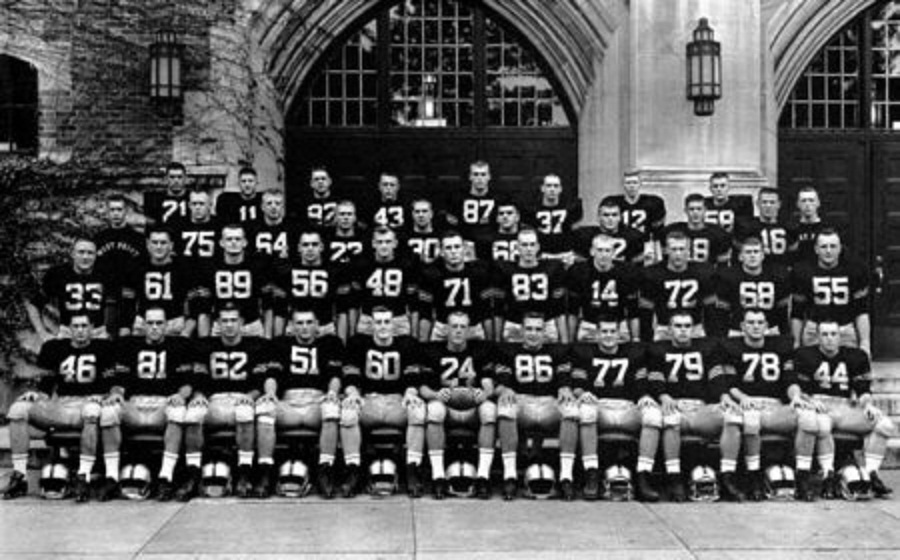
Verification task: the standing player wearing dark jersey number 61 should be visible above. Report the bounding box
[119,226,196,336]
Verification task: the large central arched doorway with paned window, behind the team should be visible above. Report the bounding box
[285,0,578,213]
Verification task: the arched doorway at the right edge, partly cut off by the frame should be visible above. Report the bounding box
[779,0,900,357]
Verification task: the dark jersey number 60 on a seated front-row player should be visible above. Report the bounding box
[344,335,422,394]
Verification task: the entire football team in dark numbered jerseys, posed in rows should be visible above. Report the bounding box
[3,161,897,501]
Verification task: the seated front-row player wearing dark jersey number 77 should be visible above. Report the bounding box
[572,317,662,502]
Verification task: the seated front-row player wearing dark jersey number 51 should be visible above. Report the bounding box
[256,309,344,498]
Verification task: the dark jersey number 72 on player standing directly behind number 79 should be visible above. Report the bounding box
[641,262,713,325]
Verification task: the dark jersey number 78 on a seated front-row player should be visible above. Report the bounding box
[722,337,797,401]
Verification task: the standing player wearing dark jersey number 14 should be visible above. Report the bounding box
[567,233,640,342]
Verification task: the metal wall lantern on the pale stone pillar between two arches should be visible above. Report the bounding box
[687,18,722,117]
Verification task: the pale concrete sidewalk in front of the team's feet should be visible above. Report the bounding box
[0,471,900,560]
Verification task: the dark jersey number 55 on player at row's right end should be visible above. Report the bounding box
[791,259,869,325]
